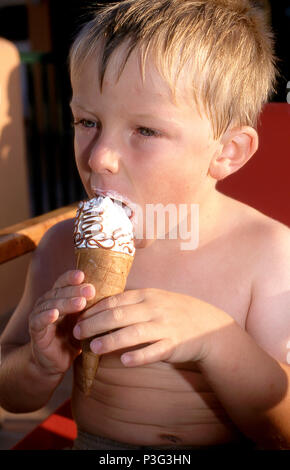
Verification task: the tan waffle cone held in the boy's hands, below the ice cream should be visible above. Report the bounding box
[75,248,134,395]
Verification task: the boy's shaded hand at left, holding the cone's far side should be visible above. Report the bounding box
[29,270,95,374]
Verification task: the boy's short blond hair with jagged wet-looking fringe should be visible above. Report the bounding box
[69,0,276,139]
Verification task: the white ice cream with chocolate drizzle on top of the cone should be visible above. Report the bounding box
[74,196,135,256]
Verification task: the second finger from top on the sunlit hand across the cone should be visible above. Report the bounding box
[73,303,151,339]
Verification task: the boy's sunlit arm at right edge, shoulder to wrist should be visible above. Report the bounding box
[201,224,290,448]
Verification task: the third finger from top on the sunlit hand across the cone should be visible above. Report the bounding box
[90,322,160,354]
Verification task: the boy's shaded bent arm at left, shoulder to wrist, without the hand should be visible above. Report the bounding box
[0,223,74,413]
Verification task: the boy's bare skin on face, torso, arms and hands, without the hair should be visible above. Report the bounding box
[0,46,290,447]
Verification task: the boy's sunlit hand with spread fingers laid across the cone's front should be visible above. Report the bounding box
[74,289,234,366]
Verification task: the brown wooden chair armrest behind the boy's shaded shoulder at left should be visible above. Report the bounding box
[0,203,77,264]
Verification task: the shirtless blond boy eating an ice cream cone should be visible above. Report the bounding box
[0,0,290,449]
